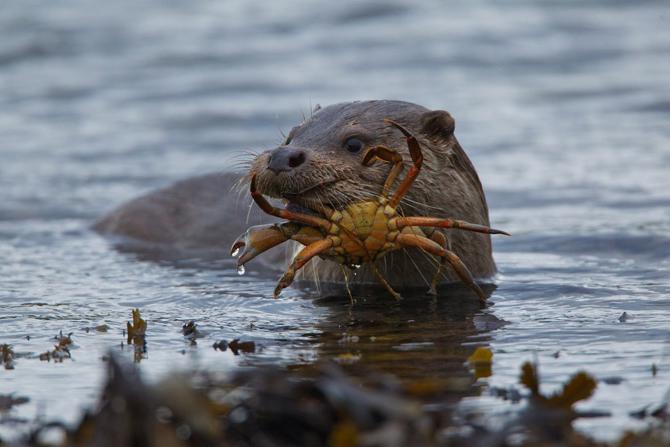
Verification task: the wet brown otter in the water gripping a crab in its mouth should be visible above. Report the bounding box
[95,100,496,290]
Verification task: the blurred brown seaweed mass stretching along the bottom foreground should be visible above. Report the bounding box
[9,356,670,447]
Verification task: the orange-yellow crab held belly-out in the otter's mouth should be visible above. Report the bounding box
[231,119,509,302]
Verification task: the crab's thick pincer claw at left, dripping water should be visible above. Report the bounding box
[230,222,323,266]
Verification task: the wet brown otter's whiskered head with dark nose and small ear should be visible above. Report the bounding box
[249,101,457,215]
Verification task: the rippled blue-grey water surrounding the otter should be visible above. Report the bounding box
[0,0,670,439]
